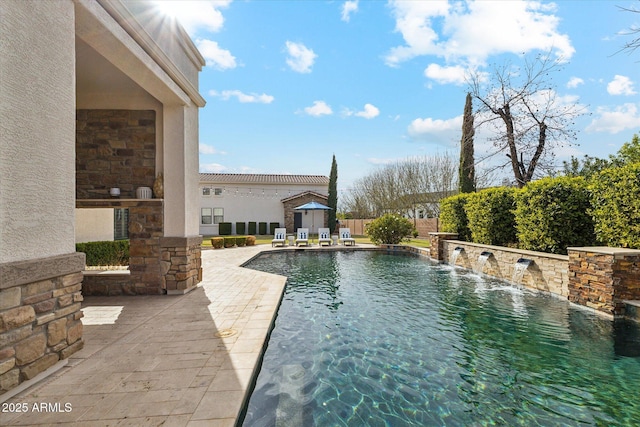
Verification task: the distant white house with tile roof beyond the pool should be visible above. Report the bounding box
[199,173,329,236]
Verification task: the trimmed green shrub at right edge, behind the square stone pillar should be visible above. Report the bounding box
[589,163,640,249]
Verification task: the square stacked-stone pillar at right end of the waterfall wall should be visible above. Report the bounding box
[569,247,640,316]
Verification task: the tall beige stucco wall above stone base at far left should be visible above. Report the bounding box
[0,0,75,263]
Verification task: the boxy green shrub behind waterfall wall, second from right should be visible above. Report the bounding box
[514,177,595,254]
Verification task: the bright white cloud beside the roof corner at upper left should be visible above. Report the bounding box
[155,0,231,37]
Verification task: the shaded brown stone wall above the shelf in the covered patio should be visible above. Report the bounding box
[76,110,156,199]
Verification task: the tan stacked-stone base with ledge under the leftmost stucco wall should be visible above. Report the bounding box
[0,253,85,394]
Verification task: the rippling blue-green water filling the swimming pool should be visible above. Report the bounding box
[244,251,640,427]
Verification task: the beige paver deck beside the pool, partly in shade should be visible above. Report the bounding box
[0,245,369,427]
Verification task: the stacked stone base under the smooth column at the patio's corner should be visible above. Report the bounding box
[160,236,202,295]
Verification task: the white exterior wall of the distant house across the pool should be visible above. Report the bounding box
[198,182,327,236]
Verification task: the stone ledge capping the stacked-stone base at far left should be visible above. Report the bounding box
[0,252,85,289]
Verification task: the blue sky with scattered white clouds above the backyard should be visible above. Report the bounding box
[159,0,640,191]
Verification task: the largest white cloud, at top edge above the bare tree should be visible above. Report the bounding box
[385,0,575,66]
